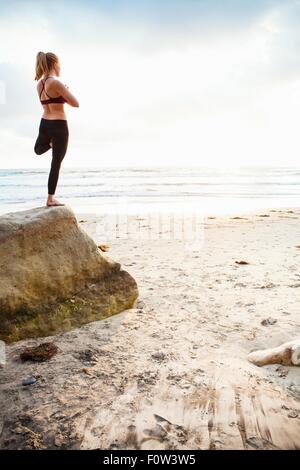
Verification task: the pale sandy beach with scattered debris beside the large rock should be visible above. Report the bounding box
[0,207,300,450]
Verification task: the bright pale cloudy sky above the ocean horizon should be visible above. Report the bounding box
[0,0,300,168]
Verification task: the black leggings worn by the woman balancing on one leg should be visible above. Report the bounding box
[34,118,69,194]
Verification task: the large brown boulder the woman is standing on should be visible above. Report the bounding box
[0,206,138,342]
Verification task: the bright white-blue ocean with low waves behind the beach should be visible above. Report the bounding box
[0,166,300,215]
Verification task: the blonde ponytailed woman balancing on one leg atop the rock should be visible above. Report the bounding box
[34,52,79,207]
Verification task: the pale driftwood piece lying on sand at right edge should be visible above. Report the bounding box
[248,339,300,366]
